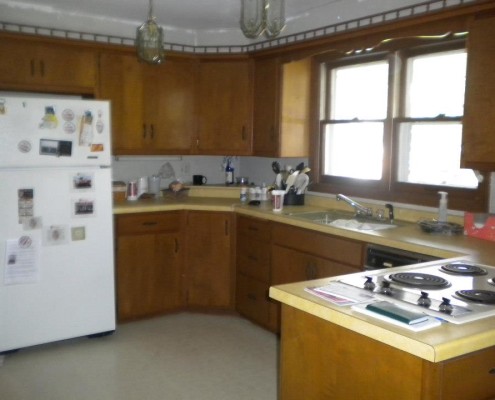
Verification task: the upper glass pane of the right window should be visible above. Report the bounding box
[406,50,466,118]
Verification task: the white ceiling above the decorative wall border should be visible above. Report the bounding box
[0,0,458,46]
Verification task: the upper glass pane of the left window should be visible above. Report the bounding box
[330,61,388,120]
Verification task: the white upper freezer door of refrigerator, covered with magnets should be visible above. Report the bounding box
[0,95,111,168]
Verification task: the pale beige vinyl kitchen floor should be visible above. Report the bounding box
[0,313,279,400]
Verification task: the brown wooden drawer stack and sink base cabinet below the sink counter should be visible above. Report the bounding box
[236,216,364,332]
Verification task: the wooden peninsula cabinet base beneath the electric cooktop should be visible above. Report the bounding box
[279,305,495,400]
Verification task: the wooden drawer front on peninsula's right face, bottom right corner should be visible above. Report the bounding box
[442,347,495,400]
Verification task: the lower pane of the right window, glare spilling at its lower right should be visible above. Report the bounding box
[398,122,478,188]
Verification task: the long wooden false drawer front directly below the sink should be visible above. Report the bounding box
[273,224,364,268]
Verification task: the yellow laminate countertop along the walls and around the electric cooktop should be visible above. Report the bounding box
[114,191,495,362]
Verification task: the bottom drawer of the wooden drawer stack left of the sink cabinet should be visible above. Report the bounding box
[236,274,270,326]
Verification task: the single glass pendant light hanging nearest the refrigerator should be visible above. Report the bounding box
[136,0,165,64]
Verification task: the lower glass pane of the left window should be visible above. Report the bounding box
[324,122,383,180]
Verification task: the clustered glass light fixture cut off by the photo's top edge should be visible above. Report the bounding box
[241,0,285,39]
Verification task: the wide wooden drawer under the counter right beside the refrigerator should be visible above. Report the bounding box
[117,211,181,235]
